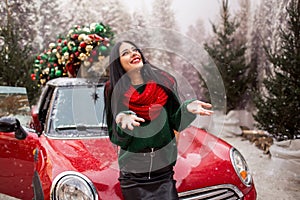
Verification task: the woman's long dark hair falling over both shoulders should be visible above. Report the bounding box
[105,41,177,141]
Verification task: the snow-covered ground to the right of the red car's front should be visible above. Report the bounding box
[223,137,300,200]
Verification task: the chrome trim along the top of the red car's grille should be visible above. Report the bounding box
[178,184,244,200]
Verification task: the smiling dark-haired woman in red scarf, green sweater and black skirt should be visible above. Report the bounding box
[105,41,212,200]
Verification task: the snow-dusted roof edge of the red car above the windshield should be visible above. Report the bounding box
[47,77,108,87]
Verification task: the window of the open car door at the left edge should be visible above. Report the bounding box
[0,86,31,126]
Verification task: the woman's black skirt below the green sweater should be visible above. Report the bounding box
[119,166,178,200]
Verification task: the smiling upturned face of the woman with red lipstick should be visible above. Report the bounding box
[119,42,143,72]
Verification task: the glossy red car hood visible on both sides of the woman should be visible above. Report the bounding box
[40,127,240,199]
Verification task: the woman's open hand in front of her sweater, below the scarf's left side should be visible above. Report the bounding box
[116,112,145,130]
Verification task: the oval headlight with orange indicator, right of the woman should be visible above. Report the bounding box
[230,148,252,186]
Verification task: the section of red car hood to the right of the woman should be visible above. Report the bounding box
[175,127,240,192]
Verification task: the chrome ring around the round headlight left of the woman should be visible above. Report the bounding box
[50,171,99,200]
